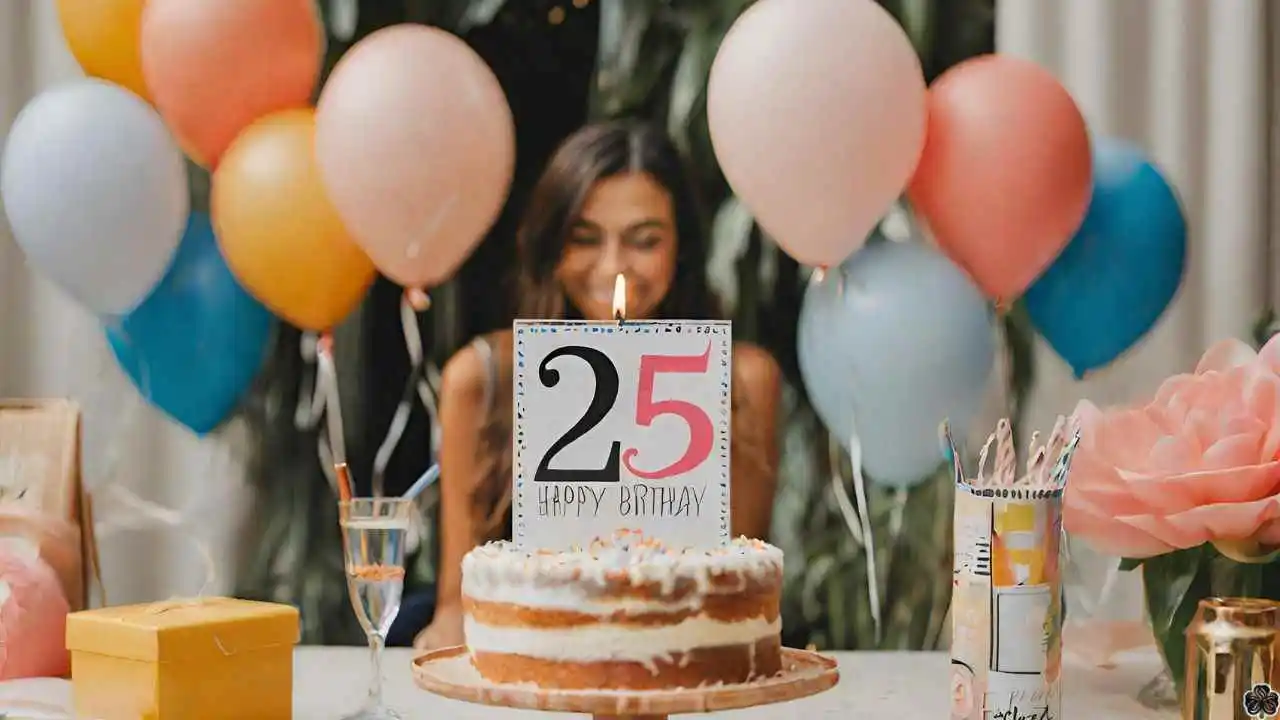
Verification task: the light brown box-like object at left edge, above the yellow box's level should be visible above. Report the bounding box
[0,400,101,610]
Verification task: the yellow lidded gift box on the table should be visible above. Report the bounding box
[67,597,298,720]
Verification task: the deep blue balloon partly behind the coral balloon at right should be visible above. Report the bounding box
[1024,138,1187,378]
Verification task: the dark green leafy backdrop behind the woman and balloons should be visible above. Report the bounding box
[237,0,1018,650]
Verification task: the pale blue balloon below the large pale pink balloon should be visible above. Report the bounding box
[797,242,996,488]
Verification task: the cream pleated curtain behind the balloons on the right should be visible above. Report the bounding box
[996,0,1280,615]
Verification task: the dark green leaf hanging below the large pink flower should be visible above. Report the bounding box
[1142,546,1213,687]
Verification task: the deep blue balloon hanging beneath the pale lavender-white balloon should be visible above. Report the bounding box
[106,213,273,436]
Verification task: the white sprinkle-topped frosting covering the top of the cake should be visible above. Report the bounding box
[462,532,782,607]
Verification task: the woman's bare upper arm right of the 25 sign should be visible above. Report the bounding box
[730,342,782,539]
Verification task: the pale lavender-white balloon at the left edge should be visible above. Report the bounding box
[0,79,191,315]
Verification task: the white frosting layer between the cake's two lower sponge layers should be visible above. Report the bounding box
[463,615,782,671]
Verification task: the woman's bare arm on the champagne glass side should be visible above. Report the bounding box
[413,345,489,650]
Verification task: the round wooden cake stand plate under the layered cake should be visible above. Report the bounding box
[413,647,840,720]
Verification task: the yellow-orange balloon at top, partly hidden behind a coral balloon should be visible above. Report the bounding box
[58,0,151,101]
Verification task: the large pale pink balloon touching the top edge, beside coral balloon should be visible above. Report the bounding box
[707,0,925,266]
